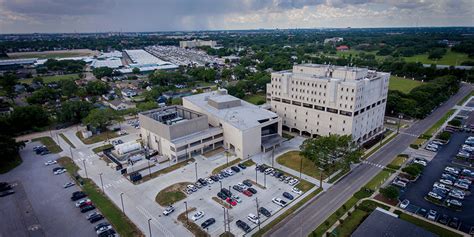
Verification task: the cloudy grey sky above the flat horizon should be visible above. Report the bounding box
[0,0,474,33]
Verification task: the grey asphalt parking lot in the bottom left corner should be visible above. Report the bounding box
[0,142,96,236]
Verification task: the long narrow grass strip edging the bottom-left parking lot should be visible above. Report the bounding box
[58,157,143,236]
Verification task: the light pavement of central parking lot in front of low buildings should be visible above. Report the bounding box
[168,162,312,236]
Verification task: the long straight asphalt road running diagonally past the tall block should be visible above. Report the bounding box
[265,84,472,237]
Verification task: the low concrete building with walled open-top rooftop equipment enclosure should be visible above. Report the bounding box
[138,106,224,162]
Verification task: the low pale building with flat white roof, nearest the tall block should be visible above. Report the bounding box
[183,89,283,159]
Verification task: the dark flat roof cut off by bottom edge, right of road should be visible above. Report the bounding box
[351,207,438,237]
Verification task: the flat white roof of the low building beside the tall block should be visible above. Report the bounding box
[183,91,278,130]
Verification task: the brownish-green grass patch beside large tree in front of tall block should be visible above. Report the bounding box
[276,151,327,180]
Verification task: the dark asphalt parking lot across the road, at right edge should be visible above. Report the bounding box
[400,132,474,232]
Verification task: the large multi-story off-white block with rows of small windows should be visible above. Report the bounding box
[267,64,390,142]
